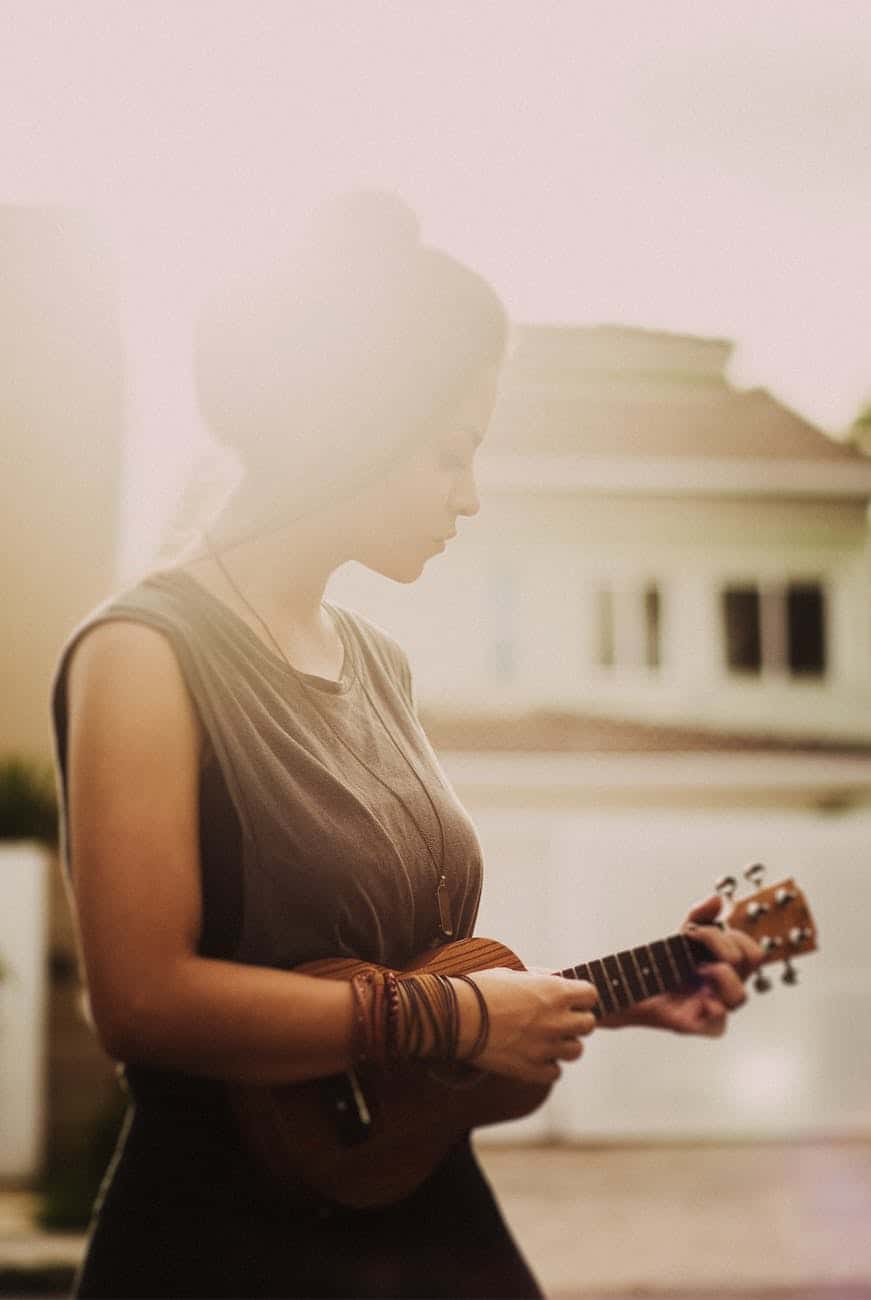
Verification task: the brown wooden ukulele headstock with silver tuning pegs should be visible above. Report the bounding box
[716,862,816,992]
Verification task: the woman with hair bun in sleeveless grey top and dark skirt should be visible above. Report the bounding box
[53,194,759,1297]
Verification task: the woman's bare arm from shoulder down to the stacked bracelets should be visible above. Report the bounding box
[68,621,351,1083]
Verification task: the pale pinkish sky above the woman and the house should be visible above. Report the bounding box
[0,0,871,559]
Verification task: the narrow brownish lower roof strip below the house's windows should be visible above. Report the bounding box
[423,711,871,758]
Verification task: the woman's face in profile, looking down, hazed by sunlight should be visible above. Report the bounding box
[354,367,499,582]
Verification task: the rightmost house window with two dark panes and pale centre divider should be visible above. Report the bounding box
[722,582,826,677]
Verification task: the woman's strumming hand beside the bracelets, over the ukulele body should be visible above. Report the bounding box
[454,967,598,1083]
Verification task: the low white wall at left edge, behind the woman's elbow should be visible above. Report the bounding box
[0,841,48,1180]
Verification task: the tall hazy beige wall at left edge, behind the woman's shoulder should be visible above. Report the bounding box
[0,207,124,755]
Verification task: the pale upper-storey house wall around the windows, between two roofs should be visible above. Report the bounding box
[330,494,871,738]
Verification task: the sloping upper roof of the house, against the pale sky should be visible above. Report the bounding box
[488,325,867,467]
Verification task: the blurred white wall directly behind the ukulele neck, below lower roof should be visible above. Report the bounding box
[459,789,871,1140]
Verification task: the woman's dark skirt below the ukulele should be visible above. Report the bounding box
[74,1089,541,1300]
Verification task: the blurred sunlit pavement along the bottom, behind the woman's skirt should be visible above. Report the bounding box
[0,1141,871,1300]
